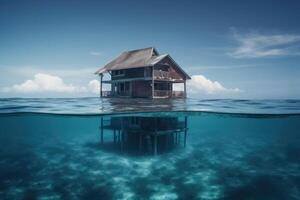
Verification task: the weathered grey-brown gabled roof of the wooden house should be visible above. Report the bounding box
[95,47,190,79]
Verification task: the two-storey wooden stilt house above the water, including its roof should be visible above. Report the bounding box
[95,47,191,98]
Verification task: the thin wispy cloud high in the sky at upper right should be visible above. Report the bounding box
[229,32,300,58]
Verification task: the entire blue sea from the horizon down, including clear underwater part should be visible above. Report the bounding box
[0,98,300,200]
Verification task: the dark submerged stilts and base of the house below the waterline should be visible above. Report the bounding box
[100,116,188,155]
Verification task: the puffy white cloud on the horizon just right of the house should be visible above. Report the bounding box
[187,75,241,95]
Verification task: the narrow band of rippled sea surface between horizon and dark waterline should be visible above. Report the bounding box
[0,98,300,114]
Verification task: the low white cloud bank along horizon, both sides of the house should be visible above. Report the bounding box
[1,73,241,97]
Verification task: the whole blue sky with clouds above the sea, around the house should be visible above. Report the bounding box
[0,0,300,99]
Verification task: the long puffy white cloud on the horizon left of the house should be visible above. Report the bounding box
[2,73,100,94]
